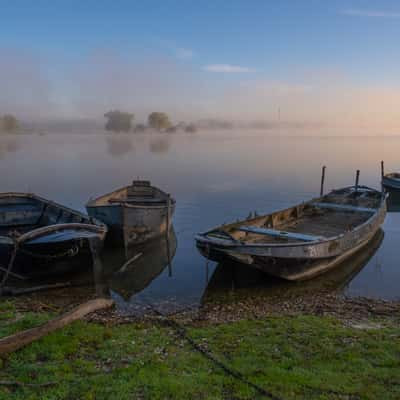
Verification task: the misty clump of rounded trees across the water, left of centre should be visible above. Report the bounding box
[104,110,197,133]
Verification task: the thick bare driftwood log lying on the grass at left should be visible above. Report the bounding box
[0,298,114,356]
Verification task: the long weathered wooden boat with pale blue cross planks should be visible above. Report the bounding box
[196,186,386,280]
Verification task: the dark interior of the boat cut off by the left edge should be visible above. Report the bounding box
[0,194,92,238]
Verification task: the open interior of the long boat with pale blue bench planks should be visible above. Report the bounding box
[207,187,382,244]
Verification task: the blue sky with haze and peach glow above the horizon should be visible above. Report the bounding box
[0,0,400,132]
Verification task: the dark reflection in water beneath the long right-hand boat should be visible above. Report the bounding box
[202,229,384,304]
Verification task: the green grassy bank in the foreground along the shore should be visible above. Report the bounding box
[0,302,400,400]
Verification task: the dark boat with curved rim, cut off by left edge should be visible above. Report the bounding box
[0,193,107,281]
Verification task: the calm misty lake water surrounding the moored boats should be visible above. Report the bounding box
[0,132,400,309]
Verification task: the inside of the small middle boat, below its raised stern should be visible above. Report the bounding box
[88,181,168,207]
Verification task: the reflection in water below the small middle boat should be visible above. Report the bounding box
[95,227,177,306]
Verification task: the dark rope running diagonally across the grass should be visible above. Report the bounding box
[146,302,281,400]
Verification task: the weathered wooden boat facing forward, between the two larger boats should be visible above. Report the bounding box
[86,180,175,247]
